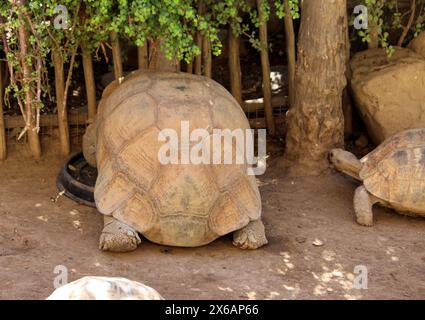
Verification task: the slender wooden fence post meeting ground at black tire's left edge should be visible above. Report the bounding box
[52,50,72,156]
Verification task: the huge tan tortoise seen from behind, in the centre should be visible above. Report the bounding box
[83,72,267,252]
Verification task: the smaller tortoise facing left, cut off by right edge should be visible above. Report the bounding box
[330,129,425,226]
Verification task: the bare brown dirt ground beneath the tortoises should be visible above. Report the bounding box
[0,143,425,299]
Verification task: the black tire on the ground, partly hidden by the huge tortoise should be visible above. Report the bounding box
[56,152,96,208]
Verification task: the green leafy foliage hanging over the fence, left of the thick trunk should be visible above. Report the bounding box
[0,0,269,121]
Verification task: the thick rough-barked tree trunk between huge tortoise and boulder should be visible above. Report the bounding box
[285,0,347,175]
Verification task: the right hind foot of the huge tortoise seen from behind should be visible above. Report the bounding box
[233,219,268,249]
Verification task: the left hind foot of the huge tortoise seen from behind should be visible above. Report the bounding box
[99,216,141,252]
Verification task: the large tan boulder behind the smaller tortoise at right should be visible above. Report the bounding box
[350,47,425,144]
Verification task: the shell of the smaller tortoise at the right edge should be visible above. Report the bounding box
[360,129,425,214]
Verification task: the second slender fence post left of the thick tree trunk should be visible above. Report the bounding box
[257,0,276,136]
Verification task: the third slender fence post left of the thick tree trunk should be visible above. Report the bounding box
[229,27,243,105]
